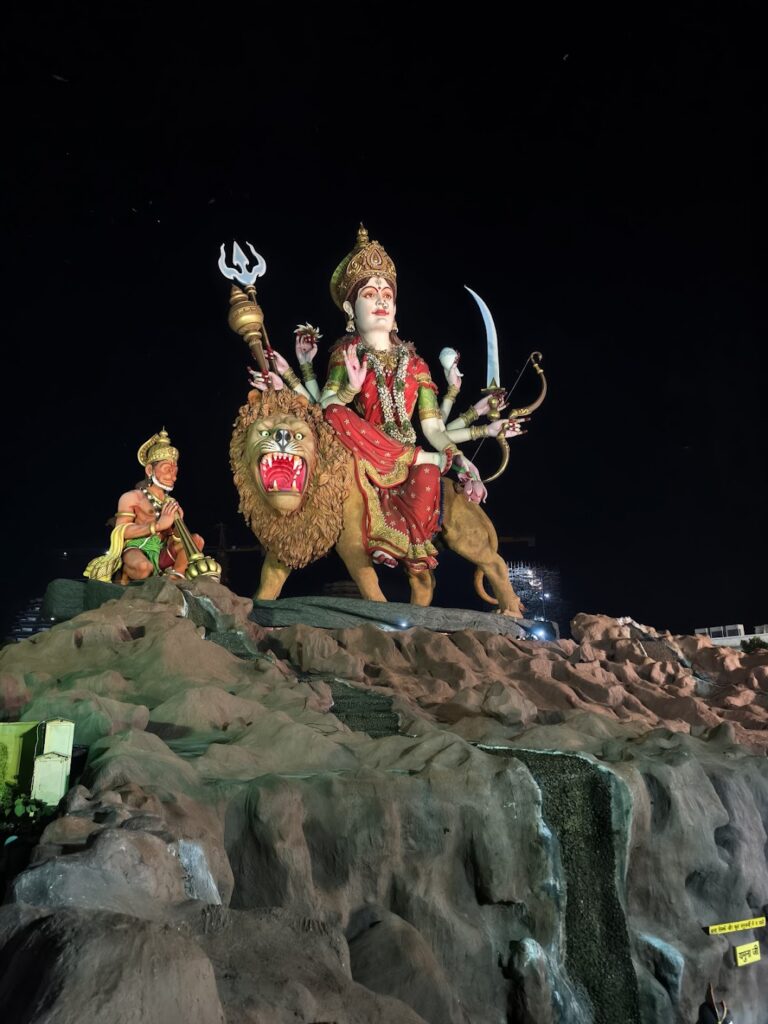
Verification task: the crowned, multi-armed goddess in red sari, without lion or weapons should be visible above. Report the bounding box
[259,225,522,572]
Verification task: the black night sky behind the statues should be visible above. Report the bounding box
[0,3,768,631]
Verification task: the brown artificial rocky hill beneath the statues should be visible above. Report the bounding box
[0,580,768,1024]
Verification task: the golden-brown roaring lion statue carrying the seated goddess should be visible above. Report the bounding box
[229,389,523,617]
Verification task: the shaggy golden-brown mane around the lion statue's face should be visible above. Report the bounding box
[229,388,351,569]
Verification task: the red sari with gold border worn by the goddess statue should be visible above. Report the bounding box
[325,344,440,570]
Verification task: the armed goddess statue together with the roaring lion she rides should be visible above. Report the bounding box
[219,226,547,616]
